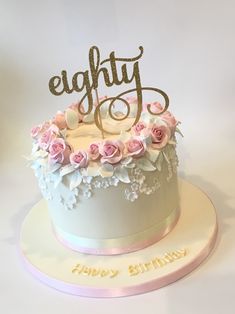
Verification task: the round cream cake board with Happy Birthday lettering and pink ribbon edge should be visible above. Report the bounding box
[20,180,217,297]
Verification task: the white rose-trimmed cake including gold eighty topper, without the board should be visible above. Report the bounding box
[30,46,184,254]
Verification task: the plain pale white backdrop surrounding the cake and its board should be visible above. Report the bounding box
[0,0,235,314]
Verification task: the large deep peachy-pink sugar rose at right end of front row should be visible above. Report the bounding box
[149,124,171,149]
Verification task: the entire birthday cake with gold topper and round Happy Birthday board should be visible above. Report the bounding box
[20,46,217,297]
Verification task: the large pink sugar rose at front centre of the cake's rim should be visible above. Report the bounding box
[99,140,124,164]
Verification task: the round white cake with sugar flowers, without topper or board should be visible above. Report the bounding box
[30,99,180,254]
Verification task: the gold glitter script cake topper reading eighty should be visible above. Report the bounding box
[49,46,169,134]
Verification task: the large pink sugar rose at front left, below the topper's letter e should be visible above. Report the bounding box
[49,138,71,165]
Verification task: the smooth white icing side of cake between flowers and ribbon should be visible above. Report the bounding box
[48,169,179,239]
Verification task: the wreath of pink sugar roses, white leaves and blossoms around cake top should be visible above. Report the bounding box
[29,99,181,209]
